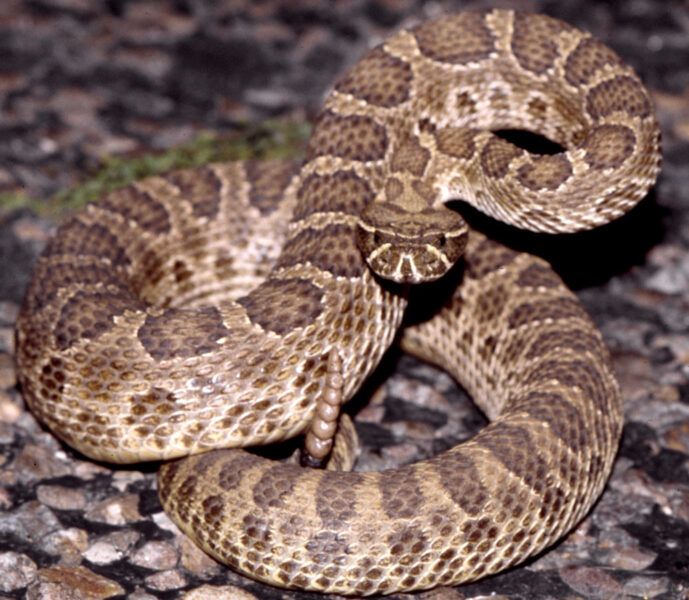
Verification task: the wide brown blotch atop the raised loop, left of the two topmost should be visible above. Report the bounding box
[411,12,495,65]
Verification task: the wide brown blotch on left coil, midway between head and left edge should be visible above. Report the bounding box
[137,306,230,361]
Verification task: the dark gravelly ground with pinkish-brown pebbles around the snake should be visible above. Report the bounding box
[0,0,689,600]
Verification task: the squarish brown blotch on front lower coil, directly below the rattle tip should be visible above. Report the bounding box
[316,471,363,530]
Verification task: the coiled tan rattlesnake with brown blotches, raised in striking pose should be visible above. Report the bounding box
[17,10,660,594]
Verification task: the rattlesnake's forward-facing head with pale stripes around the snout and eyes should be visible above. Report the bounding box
[358,202,469,283]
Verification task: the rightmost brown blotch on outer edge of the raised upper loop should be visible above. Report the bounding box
[586,75,651,120]
